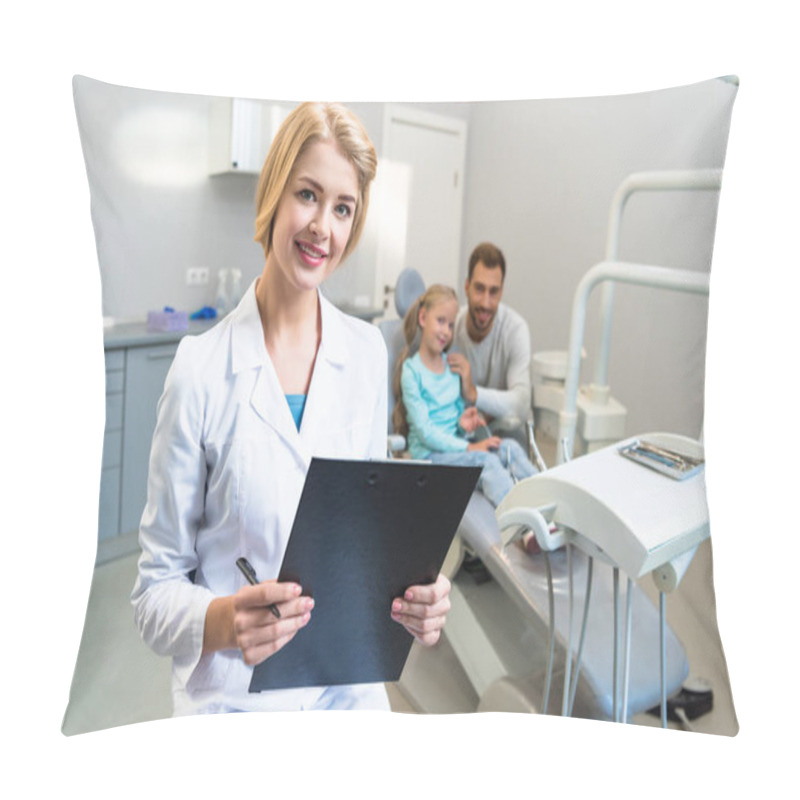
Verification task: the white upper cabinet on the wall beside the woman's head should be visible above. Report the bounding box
[209,97,290,175]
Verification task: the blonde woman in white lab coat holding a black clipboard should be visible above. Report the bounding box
[132,103,450,714]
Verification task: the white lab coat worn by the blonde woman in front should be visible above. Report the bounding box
[131,282,389,714]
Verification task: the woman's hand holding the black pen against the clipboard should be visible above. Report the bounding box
[203,581,314,666]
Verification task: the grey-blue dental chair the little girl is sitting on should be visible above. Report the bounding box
[378,269,689,722]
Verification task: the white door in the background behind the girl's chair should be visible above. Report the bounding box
[375,104,467,316]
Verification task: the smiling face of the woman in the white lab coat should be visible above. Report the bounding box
[267,140,359,289]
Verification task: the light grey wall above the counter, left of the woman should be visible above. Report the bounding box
[74,79,263,319]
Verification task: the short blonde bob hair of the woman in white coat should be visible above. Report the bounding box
[255,103,378,261]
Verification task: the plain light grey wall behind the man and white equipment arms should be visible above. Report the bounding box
[462,80,736,436]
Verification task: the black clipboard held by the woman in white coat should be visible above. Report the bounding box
[250,458,481,692]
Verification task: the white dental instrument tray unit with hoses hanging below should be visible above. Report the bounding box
[497,434,709,725]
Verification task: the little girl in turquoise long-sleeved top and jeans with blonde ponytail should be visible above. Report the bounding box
[392,284,537,506]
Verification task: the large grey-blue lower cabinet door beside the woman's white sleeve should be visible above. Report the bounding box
[120,344,178,533]
